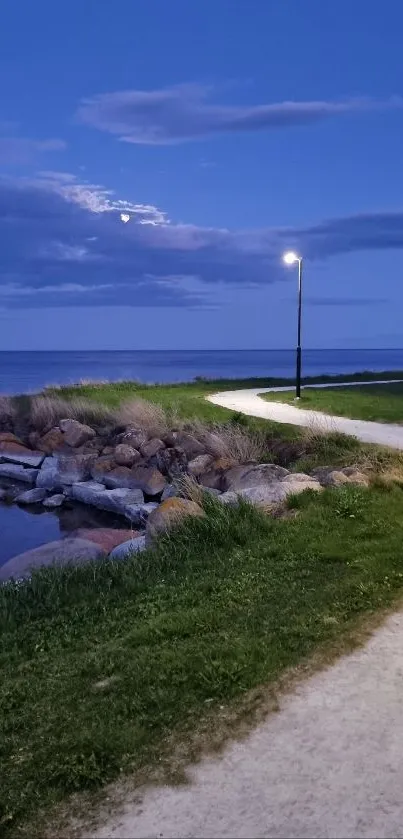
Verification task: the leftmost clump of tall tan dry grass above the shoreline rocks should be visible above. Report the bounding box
[30,396,114,431]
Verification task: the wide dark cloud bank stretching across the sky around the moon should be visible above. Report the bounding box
[0,172,403,309]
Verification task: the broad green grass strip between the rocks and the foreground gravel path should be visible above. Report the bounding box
[0,487,403,837]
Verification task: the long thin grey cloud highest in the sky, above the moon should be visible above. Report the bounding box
[77,84,403,145]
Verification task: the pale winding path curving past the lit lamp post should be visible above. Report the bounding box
[206,379,403,449]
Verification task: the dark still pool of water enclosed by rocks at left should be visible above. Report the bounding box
[0,484,133,565]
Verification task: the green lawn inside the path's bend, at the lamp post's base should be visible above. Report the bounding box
[263,376,403,424]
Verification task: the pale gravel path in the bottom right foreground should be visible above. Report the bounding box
[89,613,403,839]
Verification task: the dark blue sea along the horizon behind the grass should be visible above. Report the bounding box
[0,349,403,394]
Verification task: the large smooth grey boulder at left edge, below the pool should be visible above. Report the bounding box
[0,538,105,581]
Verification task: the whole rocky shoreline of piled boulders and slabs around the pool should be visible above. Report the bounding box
[0,418,368,581]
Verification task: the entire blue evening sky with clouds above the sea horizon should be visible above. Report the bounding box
[0,0,403,350]
